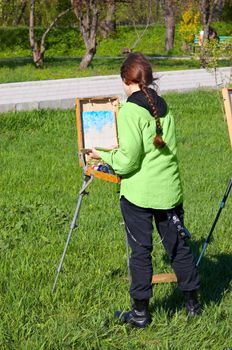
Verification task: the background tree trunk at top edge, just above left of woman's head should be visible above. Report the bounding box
[99,0,116,39]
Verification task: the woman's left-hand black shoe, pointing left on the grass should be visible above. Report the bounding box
[115,300,151,328]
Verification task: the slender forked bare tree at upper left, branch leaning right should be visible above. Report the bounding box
[29,0,72,67]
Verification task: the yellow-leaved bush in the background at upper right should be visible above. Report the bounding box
[179,6,200,44]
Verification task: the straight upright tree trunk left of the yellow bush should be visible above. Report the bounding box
[164,0,175,52]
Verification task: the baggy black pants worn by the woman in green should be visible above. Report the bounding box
[120,197,200,300]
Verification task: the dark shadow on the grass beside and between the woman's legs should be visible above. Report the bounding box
[151,239,232,316]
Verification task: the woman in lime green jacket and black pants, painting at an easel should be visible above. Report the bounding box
[90,53,200,328]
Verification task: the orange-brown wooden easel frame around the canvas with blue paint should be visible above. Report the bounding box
[76,96,120,183]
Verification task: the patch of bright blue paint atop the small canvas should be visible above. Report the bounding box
[82,111,115,132]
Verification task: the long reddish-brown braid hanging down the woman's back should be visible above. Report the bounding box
[139,83,165,148]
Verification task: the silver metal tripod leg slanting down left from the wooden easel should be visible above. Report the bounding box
[52,175,94,293]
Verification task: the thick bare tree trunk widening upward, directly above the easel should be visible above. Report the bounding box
[71,0,99,69]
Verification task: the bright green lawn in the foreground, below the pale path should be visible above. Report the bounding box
[0,91,232,350]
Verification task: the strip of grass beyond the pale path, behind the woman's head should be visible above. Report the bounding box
[0,57,203,83]
